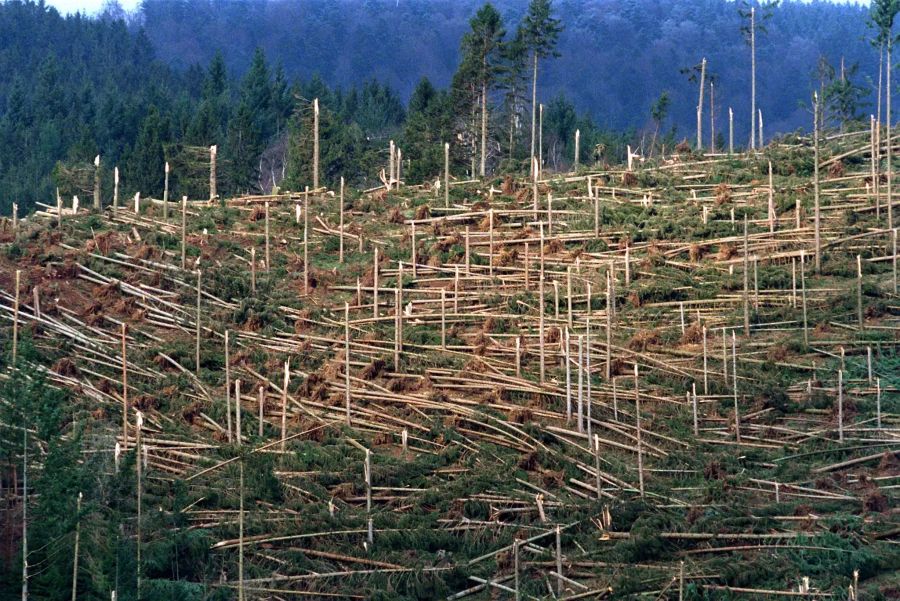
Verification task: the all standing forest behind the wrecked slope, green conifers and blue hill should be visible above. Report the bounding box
[0,0,878,213]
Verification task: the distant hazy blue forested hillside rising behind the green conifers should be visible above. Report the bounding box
[137,0,878,135]
